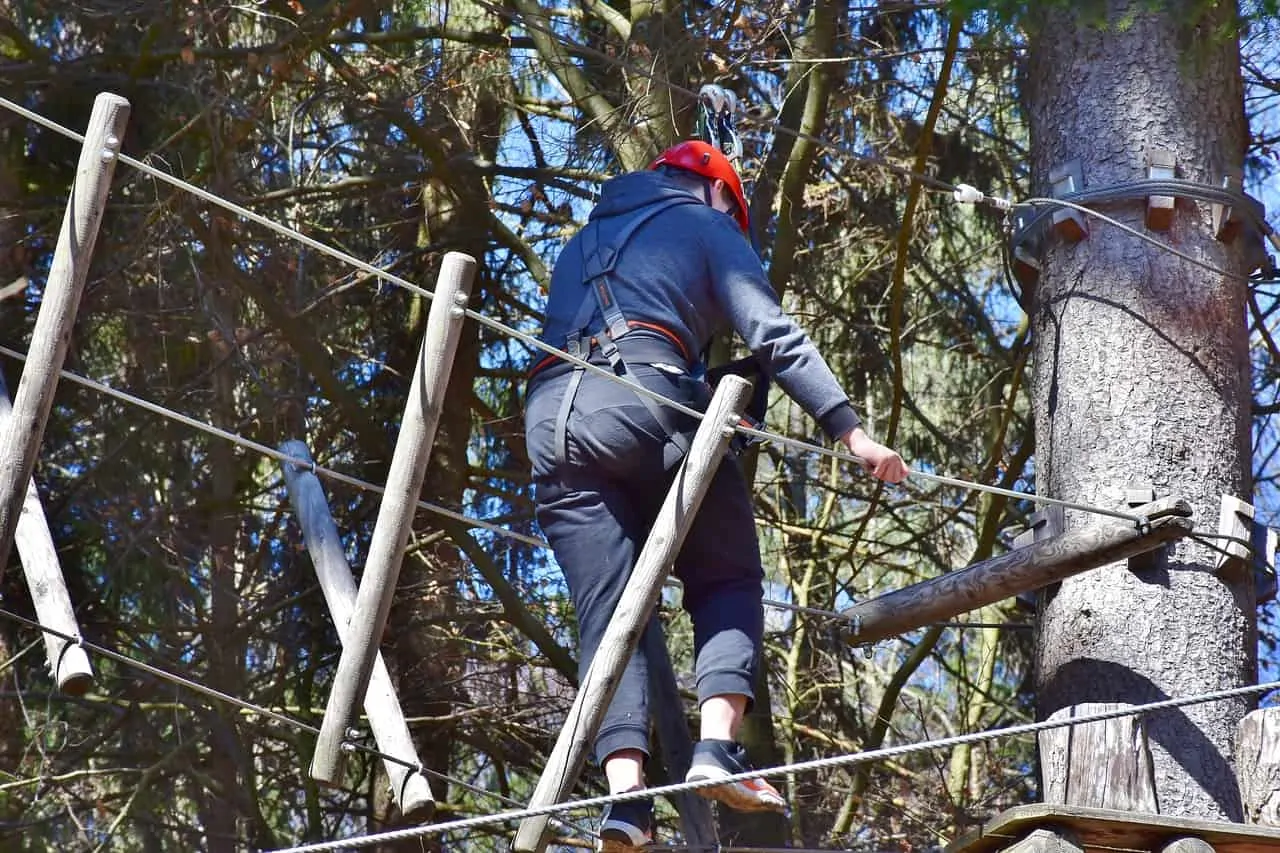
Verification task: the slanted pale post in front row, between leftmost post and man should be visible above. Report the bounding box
[311,252,476,785]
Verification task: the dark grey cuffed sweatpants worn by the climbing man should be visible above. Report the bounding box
[525,365,764,762]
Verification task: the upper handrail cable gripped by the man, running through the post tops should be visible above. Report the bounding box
[0,97,1158,527]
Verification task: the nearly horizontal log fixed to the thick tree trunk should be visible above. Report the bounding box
[842,497,1192,646]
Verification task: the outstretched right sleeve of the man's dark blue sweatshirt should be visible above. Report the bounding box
[707,216,861,438]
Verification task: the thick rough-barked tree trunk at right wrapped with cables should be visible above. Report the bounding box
[1028,0,1257,820]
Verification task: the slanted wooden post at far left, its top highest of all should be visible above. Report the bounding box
[0,92,129,576]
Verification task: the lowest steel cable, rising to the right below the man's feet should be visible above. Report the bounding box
[264,681,1280,853]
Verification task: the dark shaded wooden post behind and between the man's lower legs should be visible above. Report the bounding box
[640,613,719,849]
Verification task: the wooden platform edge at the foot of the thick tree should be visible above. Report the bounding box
[946,803,1280,853]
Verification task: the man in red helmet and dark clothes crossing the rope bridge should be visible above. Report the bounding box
[525,141,908,852]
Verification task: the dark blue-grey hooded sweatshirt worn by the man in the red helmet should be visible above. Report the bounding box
[541,172,860,438]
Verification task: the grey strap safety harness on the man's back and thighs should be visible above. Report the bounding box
[534,197,698,465]
